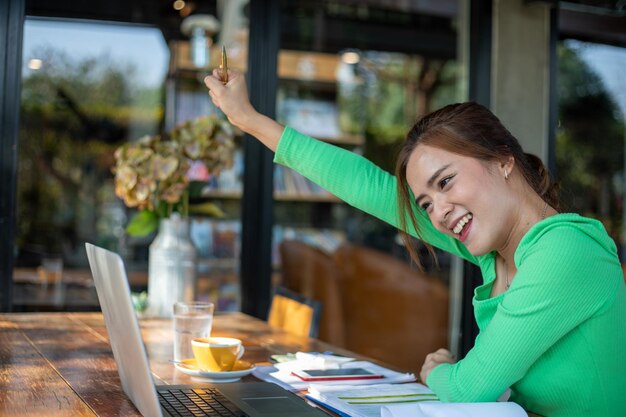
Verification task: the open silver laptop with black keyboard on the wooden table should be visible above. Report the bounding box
[85,243,328,417]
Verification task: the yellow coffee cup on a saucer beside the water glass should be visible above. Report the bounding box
[191,337,245,372]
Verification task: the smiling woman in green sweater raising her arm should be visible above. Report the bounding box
[205,72,626,417]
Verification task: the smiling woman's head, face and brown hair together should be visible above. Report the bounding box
[396,103,559,272]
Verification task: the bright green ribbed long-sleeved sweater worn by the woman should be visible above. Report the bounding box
[274,127,626,417]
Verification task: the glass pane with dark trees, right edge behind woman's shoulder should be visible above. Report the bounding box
[556,40,626,262]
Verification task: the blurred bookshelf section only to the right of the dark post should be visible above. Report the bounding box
[273,50,365,265]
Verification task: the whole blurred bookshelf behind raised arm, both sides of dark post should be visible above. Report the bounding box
[166,41,365,288]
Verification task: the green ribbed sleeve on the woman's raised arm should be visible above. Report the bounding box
[274,127,476,262]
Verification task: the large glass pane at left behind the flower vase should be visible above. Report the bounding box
[13,10,247,311]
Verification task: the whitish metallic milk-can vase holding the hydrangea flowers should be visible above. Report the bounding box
[148,213,196,317]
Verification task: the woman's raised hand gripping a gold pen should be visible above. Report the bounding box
[204,68,258,133]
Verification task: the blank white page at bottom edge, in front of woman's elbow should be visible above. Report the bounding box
[380,402,528,417]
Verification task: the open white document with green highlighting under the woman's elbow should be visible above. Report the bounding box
[307,383,527,417]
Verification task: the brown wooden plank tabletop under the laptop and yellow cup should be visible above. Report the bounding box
[0,313,354,417]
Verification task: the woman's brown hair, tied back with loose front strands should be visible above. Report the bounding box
[396,102,559,269]
